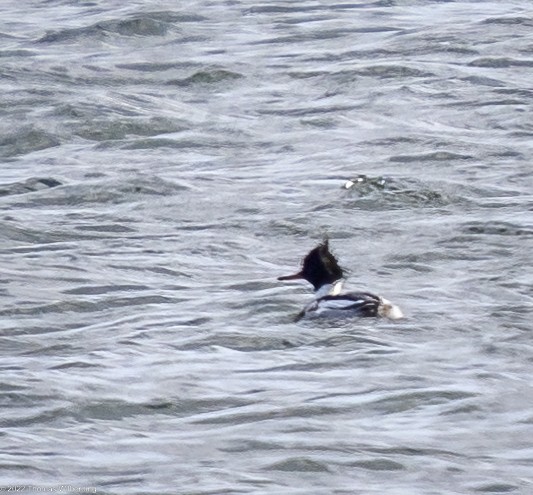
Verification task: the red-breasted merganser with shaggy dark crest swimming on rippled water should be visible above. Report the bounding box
[278,239,403,320]
